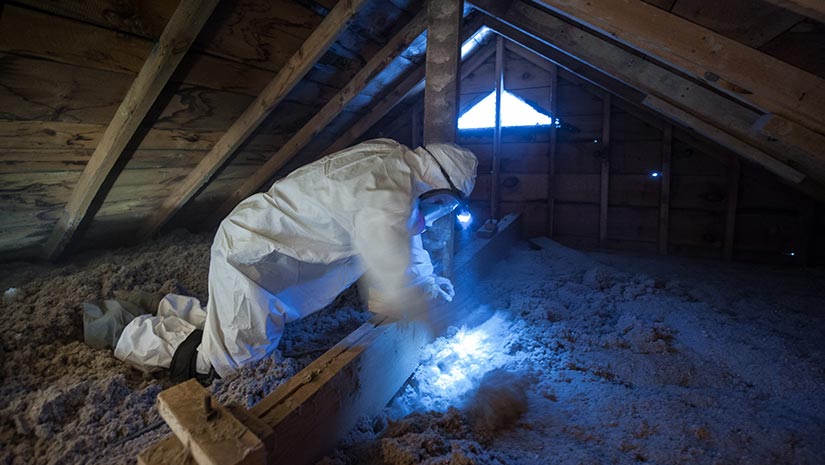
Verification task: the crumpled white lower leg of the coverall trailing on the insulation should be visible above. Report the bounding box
[114,294,209,373]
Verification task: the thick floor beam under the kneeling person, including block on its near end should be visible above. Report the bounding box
[138,215,519,465]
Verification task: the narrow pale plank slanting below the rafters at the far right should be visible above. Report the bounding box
[643,96,805,184]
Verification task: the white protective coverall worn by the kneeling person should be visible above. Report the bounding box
[115,139,478,377]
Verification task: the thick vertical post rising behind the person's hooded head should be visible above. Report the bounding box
[424,0,464,277]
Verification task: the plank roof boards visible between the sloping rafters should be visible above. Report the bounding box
[0,0,825,256]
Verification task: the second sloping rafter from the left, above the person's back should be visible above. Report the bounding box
[138,0,366,237]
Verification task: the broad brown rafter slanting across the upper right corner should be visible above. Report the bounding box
[537,0,825,138]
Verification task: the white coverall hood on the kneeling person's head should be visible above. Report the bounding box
[415,144,478,197]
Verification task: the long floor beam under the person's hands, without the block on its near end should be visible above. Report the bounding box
[138,215,519,465]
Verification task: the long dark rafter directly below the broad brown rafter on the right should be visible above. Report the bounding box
[473,0,825,199]
